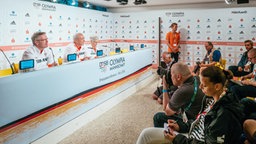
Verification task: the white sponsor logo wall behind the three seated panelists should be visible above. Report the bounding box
[0,0,113,70]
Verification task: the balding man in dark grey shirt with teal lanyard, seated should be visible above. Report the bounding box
[153,62,204,127]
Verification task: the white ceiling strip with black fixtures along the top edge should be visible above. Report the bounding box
[79,0,225,8]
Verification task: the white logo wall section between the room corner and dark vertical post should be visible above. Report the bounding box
[114,11,159,66]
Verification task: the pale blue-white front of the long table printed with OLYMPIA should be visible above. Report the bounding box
[0,48,152,127]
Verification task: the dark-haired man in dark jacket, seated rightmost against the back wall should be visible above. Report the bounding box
[228,40,253,77]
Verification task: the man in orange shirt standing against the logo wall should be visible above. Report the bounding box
[166,23,180,62]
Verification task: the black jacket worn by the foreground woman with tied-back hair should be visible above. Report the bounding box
[173,93,243,144]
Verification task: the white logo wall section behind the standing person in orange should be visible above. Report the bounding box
[161,8,256,68]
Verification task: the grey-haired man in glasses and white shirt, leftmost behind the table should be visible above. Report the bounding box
[22,32,57,70]
